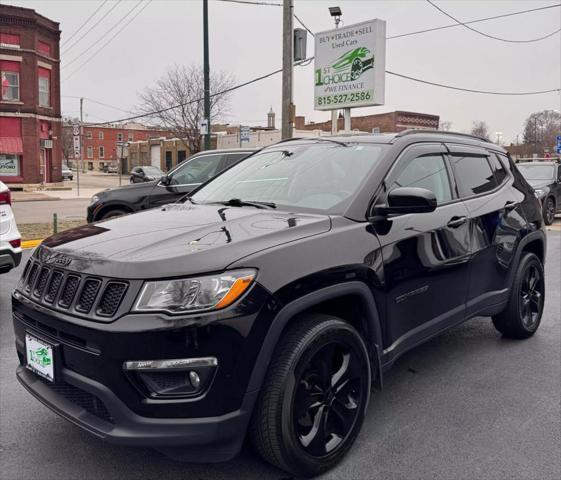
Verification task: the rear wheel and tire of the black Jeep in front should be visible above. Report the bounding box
[493,253,545,339]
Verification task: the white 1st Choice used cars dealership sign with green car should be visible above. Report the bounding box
[314,20,386,110]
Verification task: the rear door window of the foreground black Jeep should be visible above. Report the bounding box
[450,155,497,197]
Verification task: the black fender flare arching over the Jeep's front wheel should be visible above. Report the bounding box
[247,281,383,393]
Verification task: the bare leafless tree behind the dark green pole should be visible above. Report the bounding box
[137,65,234,153]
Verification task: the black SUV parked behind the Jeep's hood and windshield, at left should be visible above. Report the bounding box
[87,148,255,223]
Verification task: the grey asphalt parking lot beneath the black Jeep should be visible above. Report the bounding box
[0,230,561,480]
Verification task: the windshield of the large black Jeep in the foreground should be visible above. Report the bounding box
[192,141,386,211]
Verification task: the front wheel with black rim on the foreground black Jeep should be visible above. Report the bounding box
[249,314,371,477]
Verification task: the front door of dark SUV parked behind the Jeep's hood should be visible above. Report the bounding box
[149,153,223,208]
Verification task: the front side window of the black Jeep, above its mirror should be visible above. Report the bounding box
[390,155,452,204]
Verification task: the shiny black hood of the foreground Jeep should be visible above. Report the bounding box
[36,203,331,279]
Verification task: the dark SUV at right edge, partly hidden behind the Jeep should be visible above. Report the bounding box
[516,161,561,225]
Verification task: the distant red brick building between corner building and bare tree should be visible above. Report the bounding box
[63,123,173,172]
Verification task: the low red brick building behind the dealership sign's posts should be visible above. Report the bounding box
[295,111,440,133]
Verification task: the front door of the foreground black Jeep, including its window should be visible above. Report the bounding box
[374,144,470,357]
